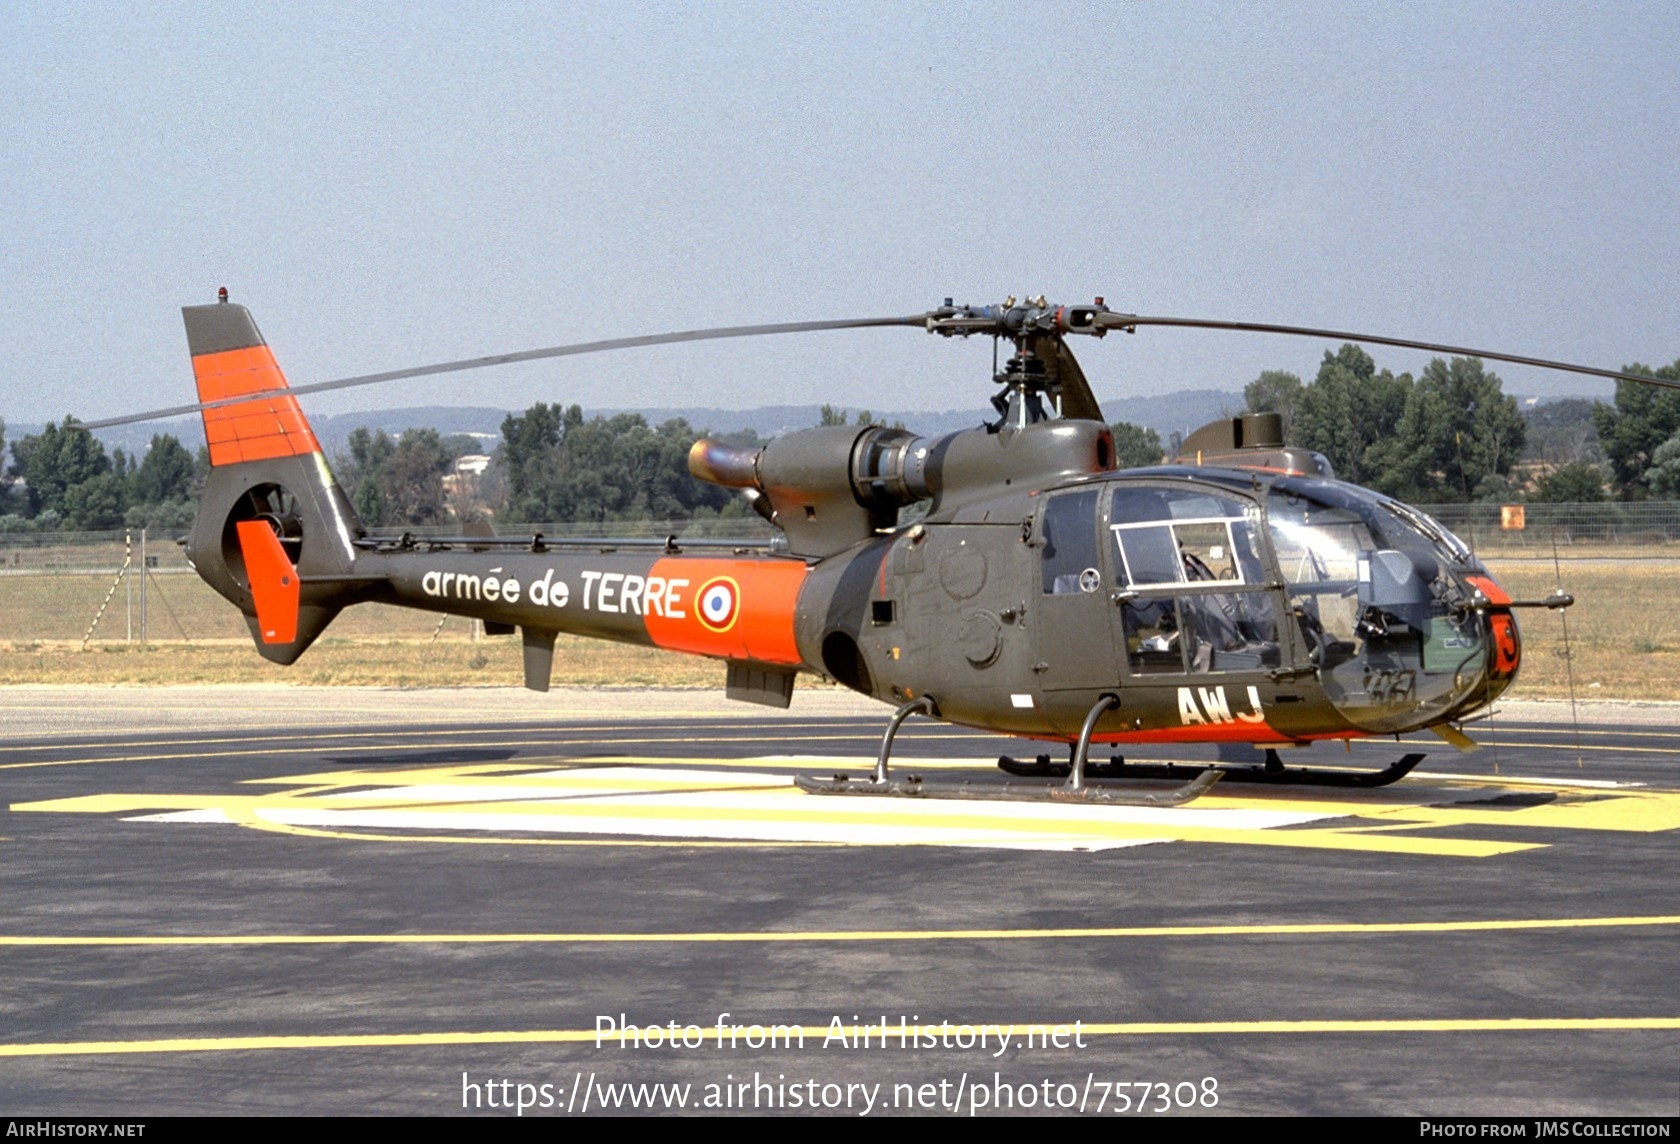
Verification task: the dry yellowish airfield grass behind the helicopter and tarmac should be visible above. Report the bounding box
[0,549,1680,701]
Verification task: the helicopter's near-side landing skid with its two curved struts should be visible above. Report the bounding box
[793,695,1223,806]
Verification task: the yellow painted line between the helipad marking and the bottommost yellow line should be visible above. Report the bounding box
[0,914,1680,947]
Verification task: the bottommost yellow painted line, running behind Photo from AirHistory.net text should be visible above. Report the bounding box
[0,1016,1680,1057]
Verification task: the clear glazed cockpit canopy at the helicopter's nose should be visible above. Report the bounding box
[1081,470,1504,732]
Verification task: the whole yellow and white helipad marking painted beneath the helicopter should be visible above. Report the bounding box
[26,756,1680,857]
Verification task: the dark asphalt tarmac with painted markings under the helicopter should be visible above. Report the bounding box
[0,687,1680,1119]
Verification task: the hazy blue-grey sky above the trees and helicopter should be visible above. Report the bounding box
[0,0,1680,422]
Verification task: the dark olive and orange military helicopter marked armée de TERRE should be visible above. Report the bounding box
[87,289,1651,805]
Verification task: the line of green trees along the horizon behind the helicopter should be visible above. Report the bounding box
[0,344,1680,533]
